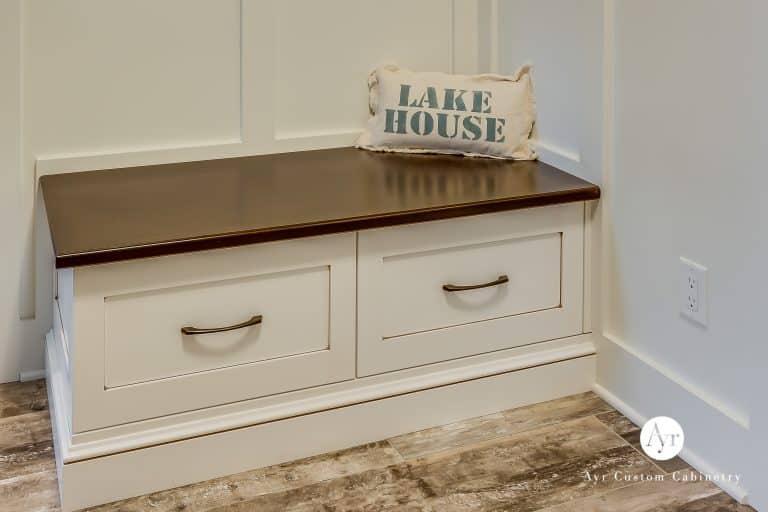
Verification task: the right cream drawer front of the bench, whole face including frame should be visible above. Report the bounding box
[358,203,584,376]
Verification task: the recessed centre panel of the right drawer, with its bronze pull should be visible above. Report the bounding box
[379,233,561,338]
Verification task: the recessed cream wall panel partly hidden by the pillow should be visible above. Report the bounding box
[273,0,453,139]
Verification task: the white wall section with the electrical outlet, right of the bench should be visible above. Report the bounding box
[599,0,768,493]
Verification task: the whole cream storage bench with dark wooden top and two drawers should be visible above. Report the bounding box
[41,148,600,510]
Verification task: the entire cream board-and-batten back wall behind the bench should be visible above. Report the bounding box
[13,0,491,384]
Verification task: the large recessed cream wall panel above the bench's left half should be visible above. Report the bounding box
[24,0,241,158]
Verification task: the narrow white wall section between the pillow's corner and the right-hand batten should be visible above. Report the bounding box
[498,0,603,184]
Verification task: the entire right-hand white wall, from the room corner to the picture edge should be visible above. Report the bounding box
[499,0,768,506]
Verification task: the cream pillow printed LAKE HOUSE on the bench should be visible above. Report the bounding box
[357,66,536,160]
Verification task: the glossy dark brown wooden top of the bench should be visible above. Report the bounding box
[40,148,600,268]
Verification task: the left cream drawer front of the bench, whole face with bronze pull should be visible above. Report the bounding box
[67,234,356,433]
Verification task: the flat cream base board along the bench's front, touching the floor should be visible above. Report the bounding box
[55,355,595,512]
